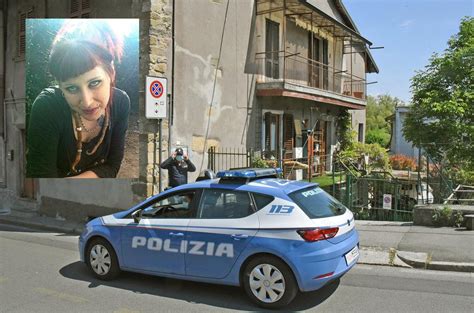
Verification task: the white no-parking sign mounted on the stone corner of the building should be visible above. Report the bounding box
[145,76,167,119]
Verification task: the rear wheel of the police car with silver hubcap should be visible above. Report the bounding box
[242,256,298,309]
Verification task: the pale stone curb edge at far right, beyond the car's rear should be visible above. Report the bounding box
[397,251,474,273]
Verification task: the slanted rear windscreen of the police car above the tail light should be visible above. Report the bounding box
[289,187,347,218]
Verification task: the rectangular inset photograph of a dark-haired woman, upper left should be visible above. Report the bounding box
[26,19,139,178]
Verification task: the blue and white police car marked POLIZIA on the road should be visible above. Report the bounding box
[79,169,359,308]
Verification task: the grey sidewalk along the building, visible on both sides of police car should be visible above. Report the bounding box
[0,212,474,272]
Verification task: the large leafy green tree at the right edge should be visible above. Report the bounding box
[403,17,474,171]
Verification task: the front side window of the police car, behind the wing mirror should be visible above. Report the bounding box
[141,191,196,218]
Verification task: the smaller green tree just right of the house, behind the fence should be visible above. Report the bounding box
[365,95,404,147]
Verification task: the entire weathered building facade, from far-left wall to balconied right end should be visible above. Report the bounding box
[0,0,378,220]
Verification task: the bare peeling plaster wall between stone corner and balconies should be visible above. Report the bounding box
[170,0,255,180]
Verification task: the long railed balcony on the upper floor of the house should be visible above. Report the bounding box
[256,51,367,108]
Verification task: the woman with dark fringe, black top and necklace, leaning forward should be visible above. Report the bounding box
[27,21,130,178]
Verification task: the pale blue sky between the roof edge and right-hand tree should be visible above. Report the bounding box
[343,0,474,103]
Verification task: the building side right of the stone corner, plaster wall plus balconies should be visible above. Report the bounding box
[170,0,378,179]
